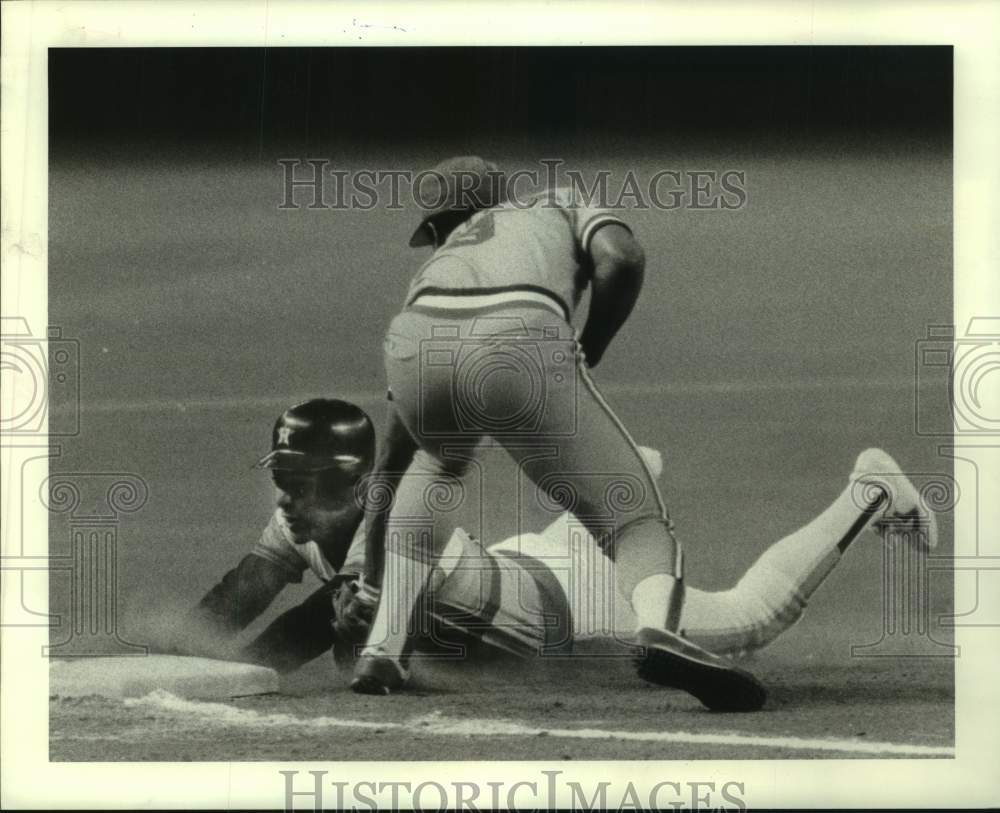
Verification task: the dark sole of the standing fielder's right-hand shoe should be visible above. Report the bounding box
[636,643,767,712]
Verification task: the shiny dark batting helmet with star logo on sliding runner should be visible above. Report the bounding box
[257,398,375,476]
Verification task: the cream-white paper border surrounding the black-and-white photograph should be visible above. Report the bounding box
[0,0,1000,809]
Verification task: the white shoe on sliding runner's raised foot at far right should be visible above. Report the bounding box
[851,449,937,549]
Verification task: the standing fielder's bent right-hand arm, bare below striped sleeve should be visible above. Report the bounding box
[580,222,646,367]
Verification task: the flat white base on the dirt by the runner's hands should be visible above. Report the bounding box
[49,655,278,699]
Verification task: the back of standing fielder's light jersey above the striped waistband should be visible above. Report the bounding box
[407,189,620,318]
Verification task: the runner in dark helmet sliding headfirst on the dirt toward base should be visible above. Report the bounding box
[169,399,936,708]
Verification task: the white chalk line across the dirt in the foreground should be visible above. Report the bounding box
[125,691,955,757]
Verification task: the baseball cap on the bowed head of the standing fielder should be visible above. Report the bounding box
[410,155,506,248]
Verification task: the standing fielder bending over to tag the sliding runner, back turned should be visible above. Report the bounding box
[352,157,765,710]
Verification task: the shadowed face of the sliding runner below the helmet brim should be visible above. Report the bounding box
[273,471,357,542]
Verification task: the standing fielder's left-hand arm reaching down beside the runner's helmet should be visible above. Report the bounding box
[364,410,417,588]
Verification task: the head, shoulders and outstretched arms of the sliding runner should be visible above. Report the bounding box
[160,399,375,672]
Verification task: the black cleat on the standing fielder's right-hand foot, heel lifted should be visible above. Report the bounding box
[636,627,767,711]
